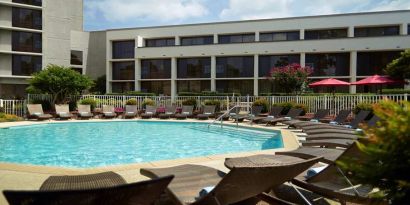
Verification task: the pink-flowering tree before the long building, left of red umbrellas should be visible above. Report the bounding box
[269,63,312,93]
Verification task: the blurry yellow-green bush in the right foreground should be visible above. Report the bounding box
[338,101,410,204]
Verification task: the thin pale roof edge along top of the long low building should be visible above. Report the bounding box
[89,9,410,32]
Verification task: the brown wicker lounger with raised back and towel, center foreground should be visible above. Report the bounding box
[141,158,319,205]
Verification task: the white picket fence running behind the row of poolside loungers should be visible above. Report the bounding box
[0,94,410,116]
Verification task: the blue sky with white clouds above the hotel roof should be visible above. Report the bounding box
[84,0,410,31]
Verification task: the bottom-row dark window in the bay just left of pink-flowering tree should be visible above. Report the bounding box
[216,80,253,95]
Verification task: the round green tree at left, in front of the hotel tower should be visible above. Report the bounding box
[27,64,94,105]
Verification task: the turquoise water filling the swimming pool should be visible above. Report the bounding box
[0,121,283,168]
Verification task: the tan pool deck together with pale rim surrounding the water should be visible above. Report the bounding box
[0,119,299,205]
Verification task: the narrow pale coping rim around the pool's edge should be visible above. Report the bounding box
[0,119,299,175]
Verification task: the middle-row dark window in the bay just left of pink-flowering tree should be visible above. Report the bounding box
[216,56,254,78]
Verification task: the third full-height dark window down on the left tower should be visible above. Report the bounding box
[12,55,42,76]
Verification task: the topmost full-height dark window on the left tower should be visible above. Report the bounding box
[12,7,43,30]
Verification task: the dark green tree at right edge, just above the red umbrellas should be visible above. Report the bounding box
[384,50,410,79]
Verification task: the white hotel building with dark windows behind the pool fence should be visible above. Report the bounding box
[0,0,410,96]
